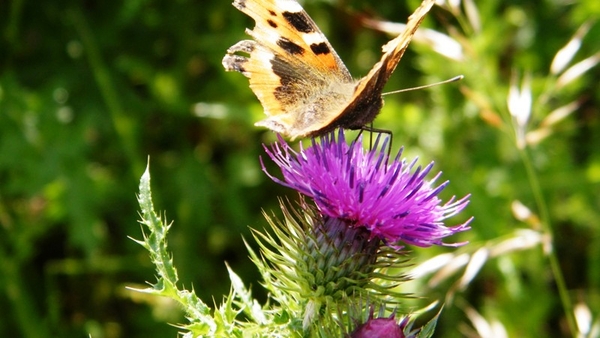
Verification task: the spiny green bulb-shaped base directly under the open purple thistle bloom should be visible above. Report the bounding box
[253,198,407,331]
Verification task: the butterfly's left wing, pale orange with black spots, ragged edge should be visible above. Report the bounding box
[223,0,354,138]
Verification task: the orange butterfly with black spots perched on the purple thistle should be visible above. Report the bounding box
[223,0,435,140]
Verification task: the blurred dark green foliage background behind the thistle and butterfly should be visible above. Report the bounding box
[0,0,600,338]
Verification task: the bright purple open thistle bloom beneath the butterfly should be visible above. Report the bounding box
[263,130,471,247]
